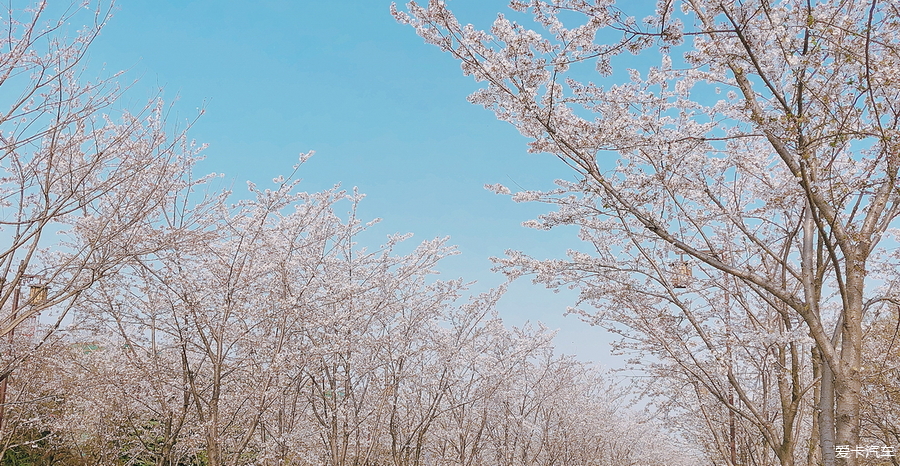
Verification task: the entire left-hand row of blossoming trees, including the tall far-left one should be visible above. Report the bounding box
[0,3,687,466]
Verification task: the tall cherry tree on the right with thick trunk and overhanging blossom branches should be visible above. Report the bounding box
[393,0,900,465]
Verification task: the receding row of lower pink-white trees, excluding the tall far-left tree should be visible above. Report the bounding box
[5,182,684,465]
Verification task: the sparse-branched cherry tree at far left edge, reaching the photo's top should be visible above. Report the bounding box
[0,2,202,444]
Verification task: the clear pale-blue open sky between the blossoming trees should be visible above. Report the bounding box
[82,0,619,366]
